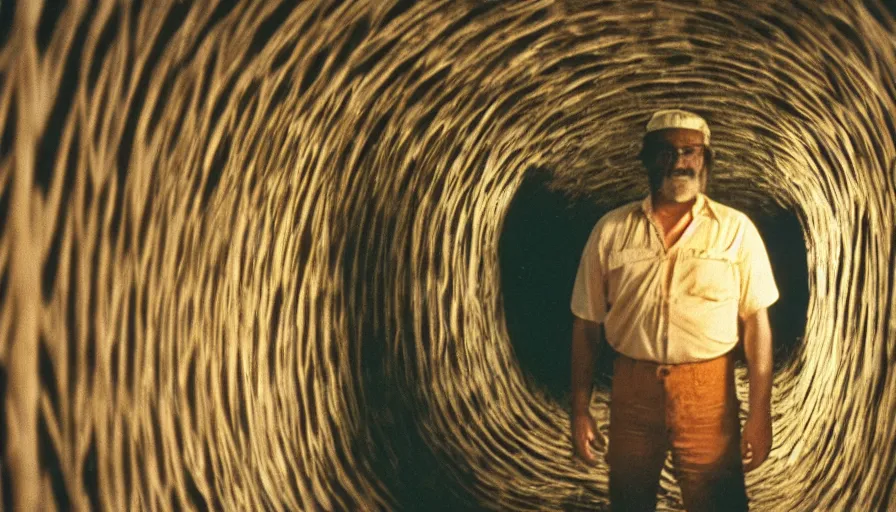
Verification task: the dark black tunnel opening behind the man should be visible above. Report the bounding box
[499,169,809,400]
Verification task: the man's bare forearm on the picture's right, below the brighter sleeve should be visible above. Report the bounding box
[744,309,772,414]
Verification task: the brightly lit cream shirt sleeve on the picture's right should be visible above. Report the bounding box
[738,219,779,318]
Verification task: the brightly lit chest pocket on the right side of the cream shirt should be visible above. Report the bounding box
[679,249,740,302]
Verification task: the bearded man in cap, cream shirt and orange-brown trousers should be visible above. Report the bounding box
[571,110,778,511]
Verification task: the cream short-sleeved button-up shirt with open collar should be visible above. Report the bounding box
[571,194,779,364]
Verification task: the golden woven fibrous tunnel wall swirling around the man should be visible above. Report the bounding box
[0,0,896,511]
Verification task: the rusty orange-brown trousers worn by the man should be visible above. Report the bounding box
[607,353,747,512]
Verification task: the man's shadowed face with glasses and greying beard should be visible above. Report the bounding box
[645,128,706,203]
